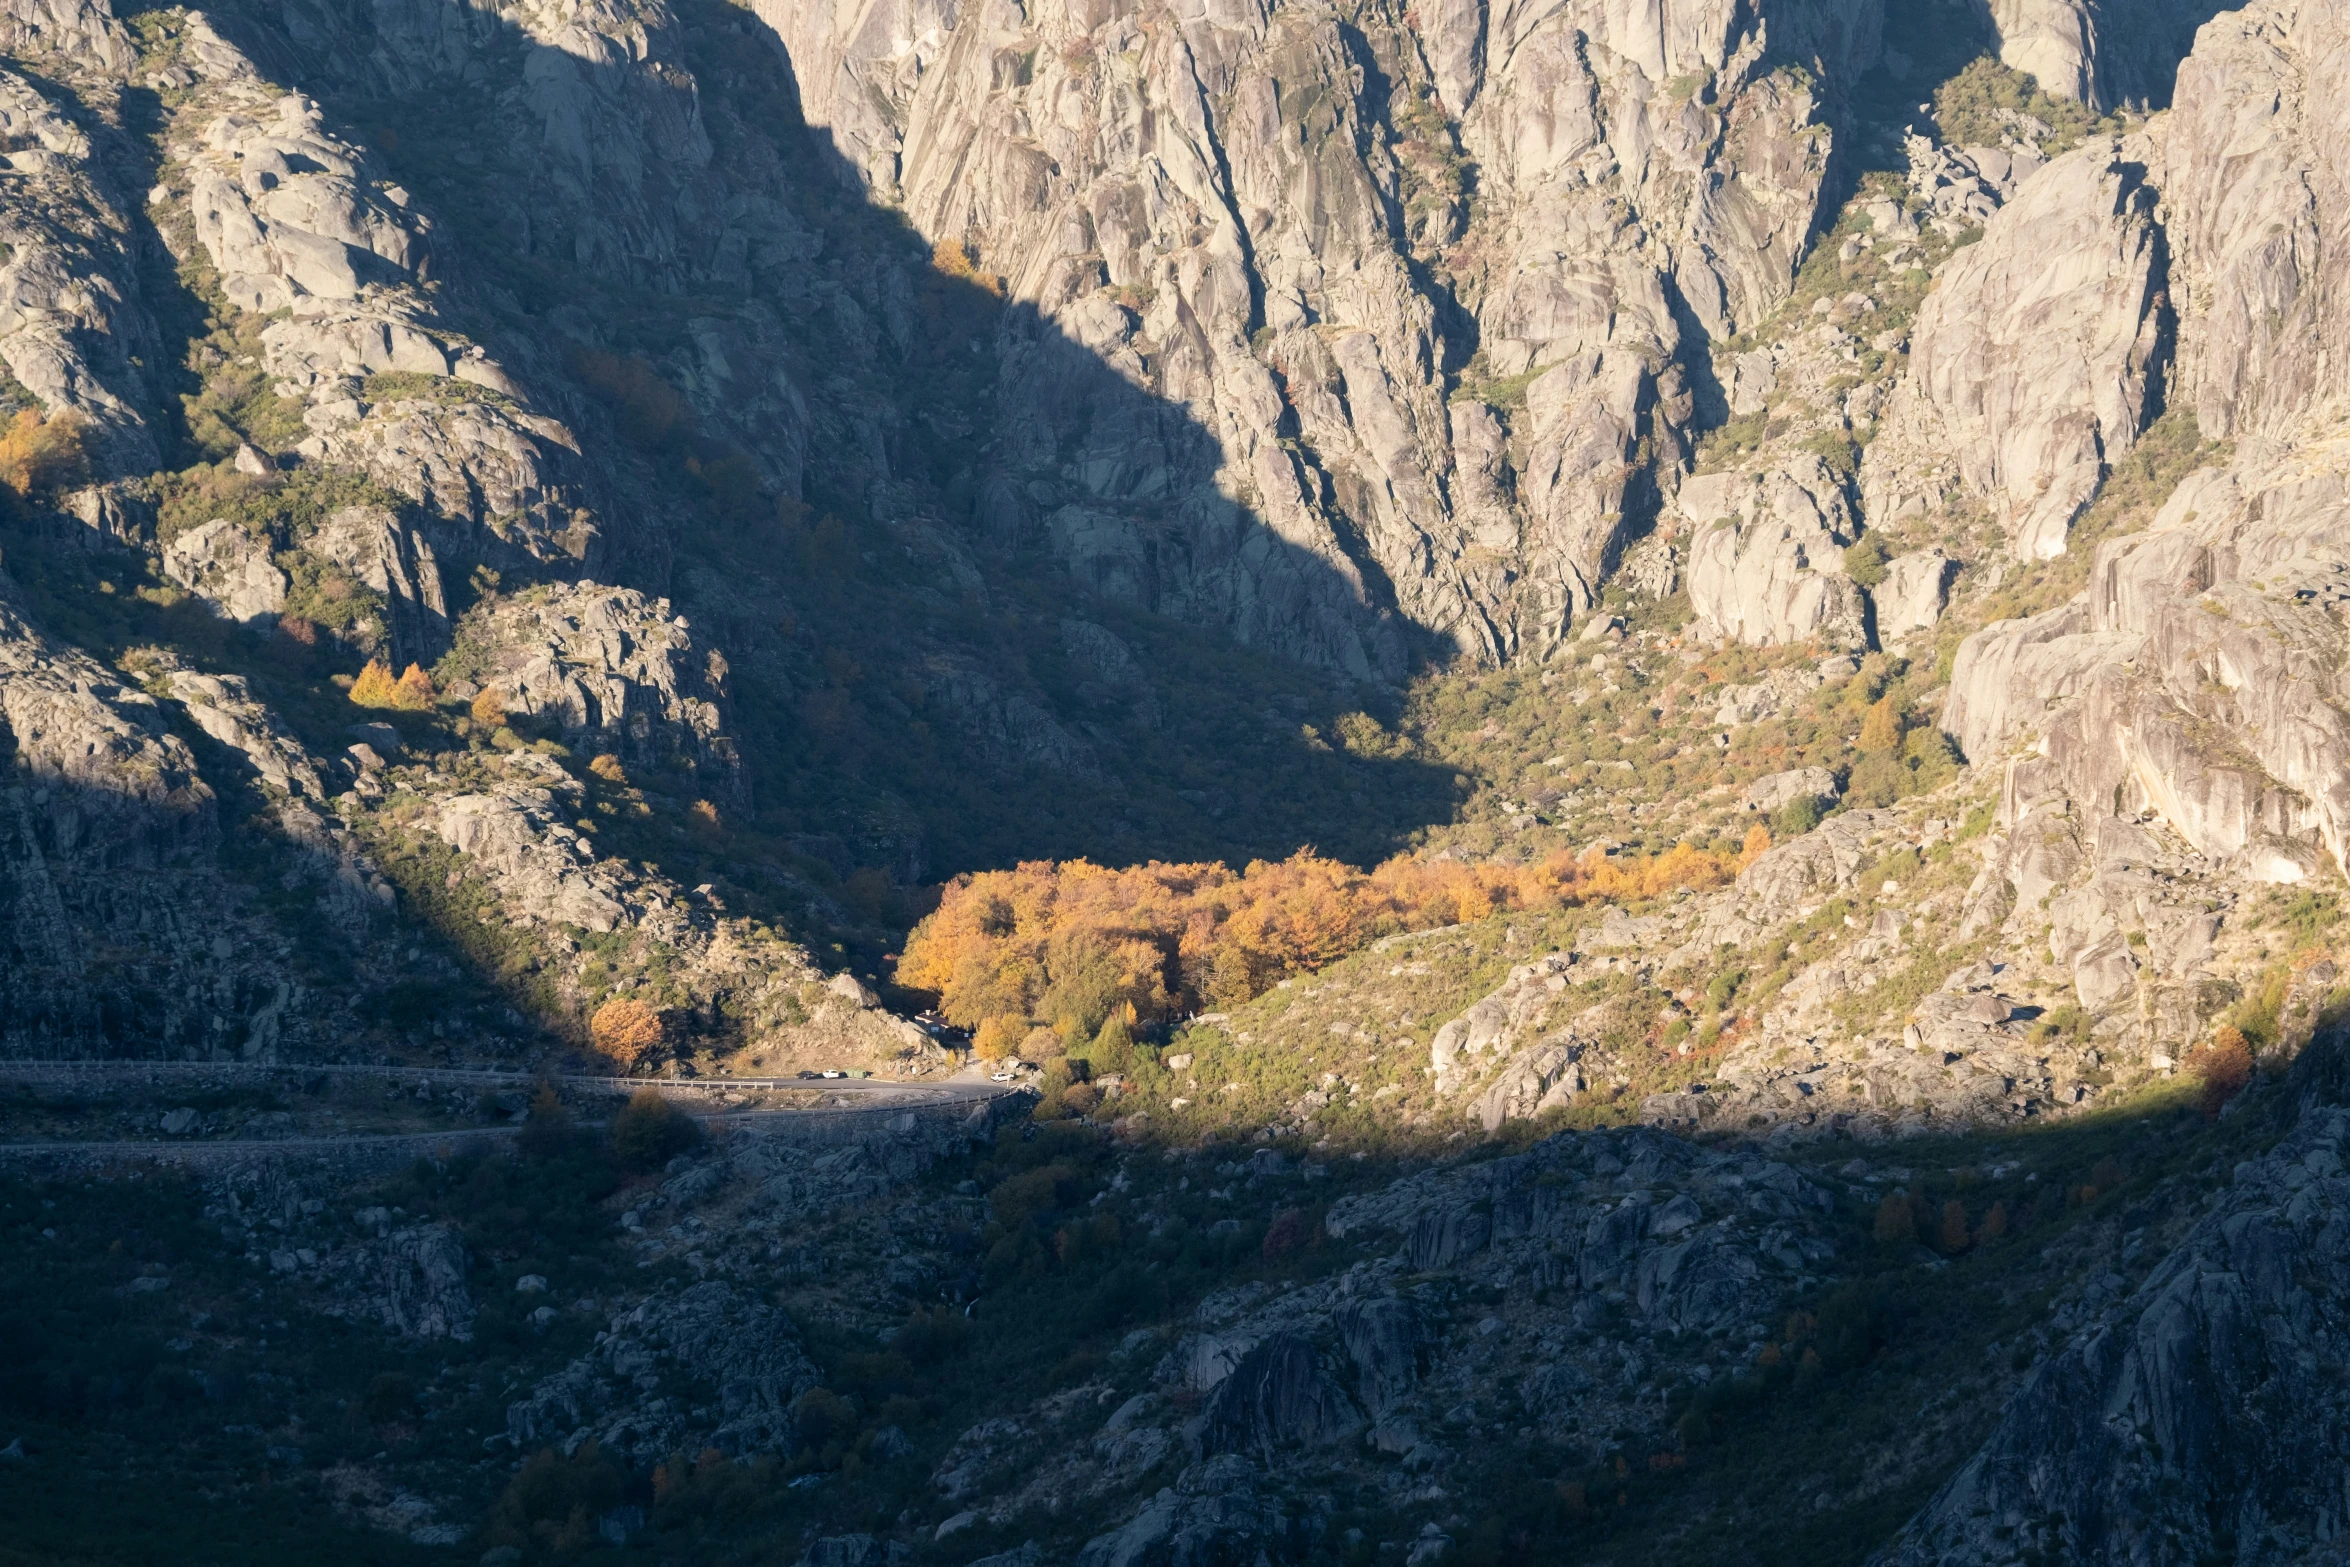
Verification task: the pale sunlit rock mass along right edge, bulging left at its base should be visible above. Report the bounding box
[1943,0,2350,881]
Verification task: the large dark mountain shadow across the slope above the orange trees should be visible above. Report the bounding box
[188,0,1455,926]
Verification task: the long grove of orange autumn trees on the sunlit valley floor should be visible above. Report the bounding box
[898,843,1737,1055]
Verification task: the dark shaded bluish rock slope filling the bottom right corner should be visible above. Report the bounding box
[1873,1052,2350,1567]
